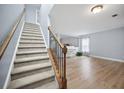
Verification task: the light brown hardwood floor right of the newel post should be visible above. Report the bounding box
[67,56,124,89]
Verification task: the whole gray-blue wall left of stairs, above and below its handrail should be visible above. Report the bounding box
[0,5,25,88]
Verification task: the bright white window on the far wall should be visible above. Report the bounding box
[82,38,89,53]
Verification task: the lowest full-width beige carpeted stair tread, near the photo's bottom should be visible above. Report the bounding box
[9,70,54,88]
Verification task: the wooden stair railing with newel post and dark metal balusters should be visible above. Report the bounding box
[48,26,67,89]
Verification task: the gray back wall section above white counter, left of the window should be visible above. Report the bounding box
[60,35,79,47]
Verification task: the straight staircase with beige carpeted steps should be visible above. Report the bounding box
[8,23,58,89]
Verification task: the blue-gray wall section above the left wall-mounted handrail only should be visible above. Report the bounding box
[0,4,24,45]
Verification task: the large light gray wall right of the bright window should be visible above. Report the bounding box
[80,27,124,60]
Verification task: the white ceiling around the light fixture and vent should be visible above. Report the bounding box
[49,4,124,36]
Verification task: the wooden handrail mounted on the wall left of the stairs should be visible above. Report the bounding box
[0,8,25,59]
